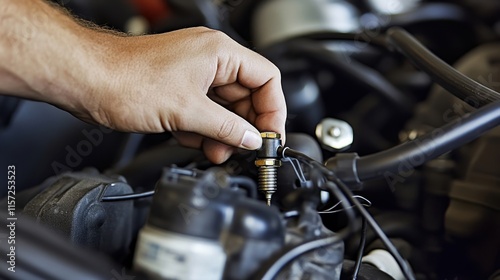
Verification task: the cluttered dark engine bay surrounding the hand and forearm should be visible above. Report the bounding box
[0,0,500,280]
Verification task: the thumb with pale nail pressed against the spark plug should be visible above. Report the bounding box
[179,98,262,150]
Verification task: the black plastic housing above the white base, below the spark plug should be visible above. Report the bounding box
[147,168,285,279]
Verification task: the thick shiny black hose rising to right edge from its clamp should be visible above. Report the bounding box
[354,101,500,181]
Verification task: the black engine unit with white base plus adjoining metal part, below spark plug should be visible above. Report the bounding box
[134,168,343,279]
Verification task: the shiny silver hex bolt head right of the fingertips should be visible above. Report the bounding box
[316,118,354,151]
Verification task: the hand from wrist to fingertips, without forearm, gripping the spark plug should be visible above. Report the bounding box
[86,27,286,163]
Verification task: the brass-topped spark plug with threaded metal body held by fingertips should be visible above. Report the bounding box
[255,132,281,206]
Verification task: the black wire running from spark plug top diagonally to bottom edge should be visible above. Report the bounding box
[278,148,415,280]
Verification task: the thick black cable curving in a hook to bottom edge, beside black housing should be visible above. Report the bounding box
[255,177,357,280]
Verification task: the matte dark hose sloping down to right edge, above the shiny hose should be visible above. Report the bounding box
[387,27,500,108]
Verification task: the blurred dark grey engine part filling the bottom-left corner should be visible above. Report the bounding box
[0,212,114,280]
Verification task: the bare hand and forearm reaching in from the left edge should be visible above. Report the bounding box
[0,0,286,163]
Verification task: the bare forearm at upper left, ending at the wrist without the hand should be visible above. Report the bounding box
[0,0,111,114]
